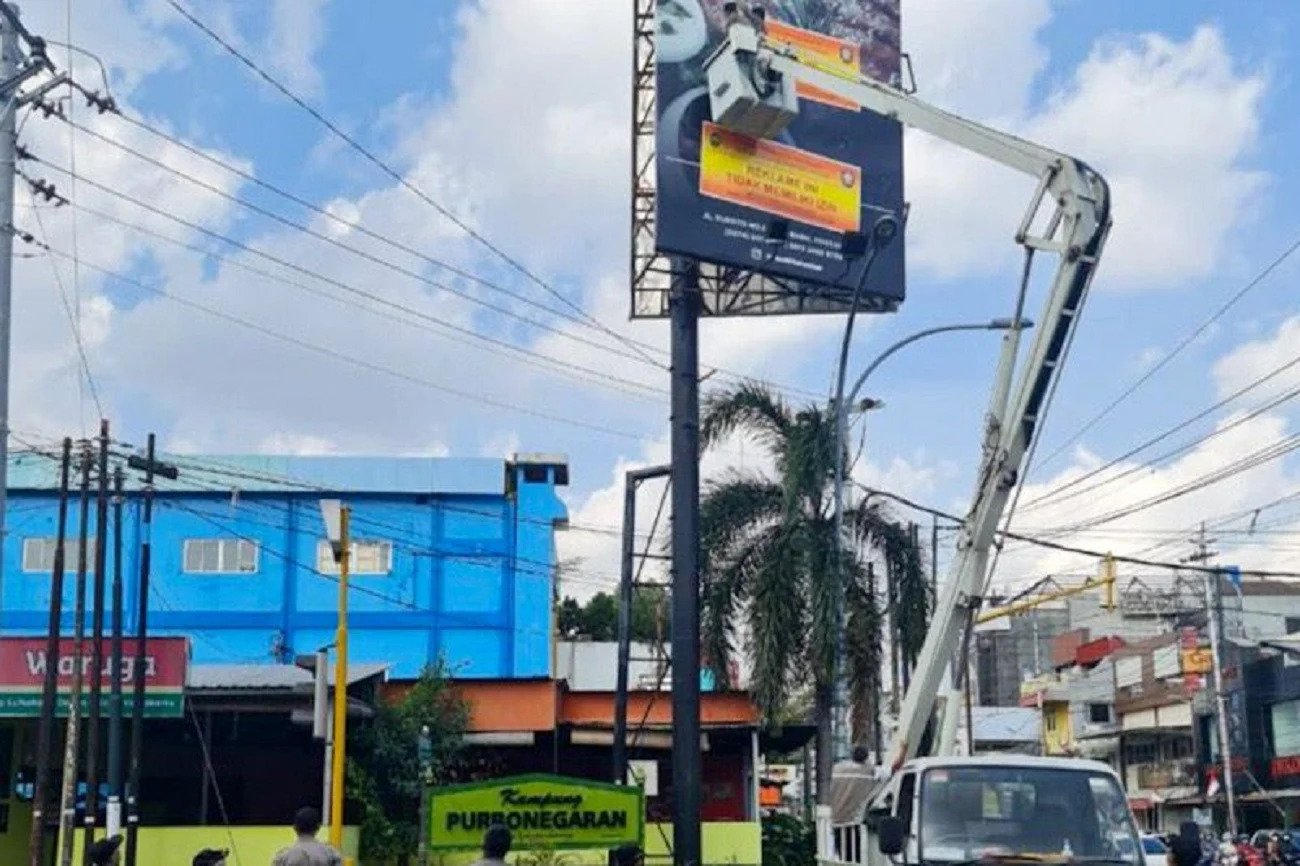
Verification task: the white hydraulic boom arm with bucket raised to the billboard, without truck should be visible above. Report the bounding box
[707,4,1110,770]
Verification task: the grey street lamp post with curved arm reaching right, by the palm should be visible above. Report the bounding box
[832,312,1034,761]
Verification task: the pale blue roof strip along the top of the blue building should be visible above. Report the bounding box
[8,453,568,495]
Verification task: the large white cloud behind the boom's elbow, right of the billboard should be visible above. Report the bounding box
[907,20,1266,289]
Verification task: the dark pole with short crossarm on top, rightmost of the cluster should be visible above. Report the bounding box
[126,433,178,866]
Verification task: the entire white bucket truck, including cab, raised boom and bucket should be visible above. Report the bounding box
[706,3,1141,866]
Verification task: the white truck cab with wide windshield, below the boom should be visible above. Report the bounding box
[862,755,1143,866]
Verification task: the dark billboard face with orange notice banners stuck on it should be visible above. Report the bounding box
[654,0,904,315]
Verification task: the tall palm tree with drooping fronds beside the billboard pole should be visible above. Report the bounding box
[701,384,927,801]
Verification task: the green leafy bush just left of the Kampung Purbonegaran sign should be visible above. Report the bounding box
[347,662,469,866]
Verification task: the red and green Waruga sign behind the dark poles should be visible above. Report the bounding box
[0,637,190,719]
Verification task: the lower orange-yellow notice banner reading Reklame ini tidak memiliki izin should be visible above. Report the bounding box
[699,122,862,231]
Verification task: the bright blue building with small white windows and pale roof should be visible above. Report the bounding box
[0,454,568,679]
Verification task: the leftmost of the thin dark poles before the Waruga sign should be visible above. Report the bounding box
[27,438,73,866]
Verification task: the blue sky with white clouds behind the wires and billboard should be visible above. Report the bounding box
[12,0,1300,596]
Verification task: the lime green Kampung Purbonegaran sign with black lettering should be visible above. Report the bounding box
[429,775,645,850]
